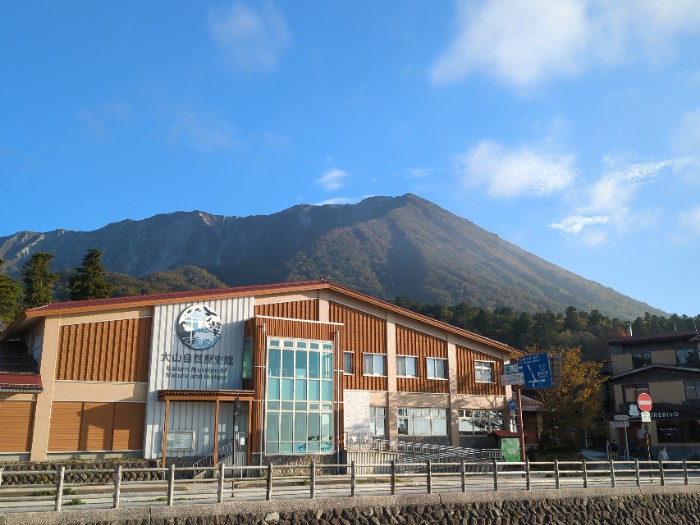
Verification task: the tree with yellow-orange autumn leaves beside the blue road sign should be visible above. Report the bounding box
[537,347,605,453]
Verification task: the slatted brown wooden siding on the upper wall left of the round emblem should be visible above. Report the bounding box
[56,317,152,382]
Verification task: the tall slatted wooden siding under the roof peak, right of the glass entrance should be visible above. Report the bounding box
[329,301,389,390]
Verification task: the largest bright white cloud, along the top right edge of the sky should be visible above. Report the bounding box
[431,0,700,88]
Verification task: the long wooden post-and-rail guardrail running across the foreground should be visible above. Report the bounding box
[0,460,700,512]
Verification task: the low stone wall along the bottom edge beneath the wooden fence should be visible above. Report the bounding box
[0,487,700,525]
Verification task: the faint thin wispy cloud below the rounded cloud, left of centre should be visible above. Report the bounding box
[167,107,238,151]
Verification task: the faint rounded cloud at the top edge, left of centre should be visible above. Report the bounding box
[209,3,291,71]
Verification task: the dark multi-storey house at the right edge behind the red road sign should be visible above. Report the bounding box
[607,331,700,459]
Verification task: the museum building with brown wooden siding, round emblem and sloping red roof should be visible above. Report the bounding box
[0,281,521,464]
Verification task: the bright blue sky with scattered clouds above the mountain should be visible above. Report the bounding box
[0,0,700,315]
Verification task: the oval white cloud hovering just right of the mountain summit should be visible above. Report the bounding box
[457,141,576,198]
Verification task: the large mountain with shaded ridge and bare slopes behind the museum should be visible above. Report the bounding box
[0,194,665,319]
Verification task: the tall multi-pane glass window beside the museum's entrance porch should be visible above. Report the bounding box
[265,338,334,455]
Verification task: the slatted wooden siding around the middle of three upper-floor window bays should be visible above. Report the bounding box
[396,324,450,394]
